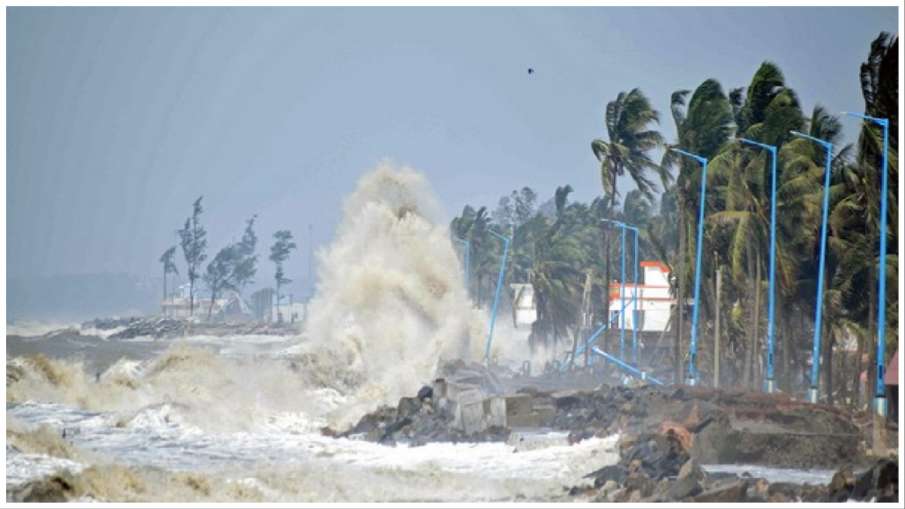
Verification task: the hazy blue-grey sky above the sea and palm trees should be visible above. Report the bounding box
[7,7,897,277]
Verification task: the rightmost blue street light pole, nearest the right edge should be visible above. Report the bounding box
[845,112,889,416]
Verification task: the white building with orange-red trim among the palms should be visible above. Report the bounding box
[610,261,675,332]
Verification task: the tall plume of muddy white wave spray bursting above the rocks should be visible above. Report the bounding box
[303,163,483,420]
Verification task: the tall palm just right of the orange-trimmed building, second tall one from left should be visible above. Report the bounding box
[655,79,733,380]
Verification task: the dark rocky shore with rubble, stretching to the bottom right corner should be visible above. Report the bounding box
[340,363,898,502]
